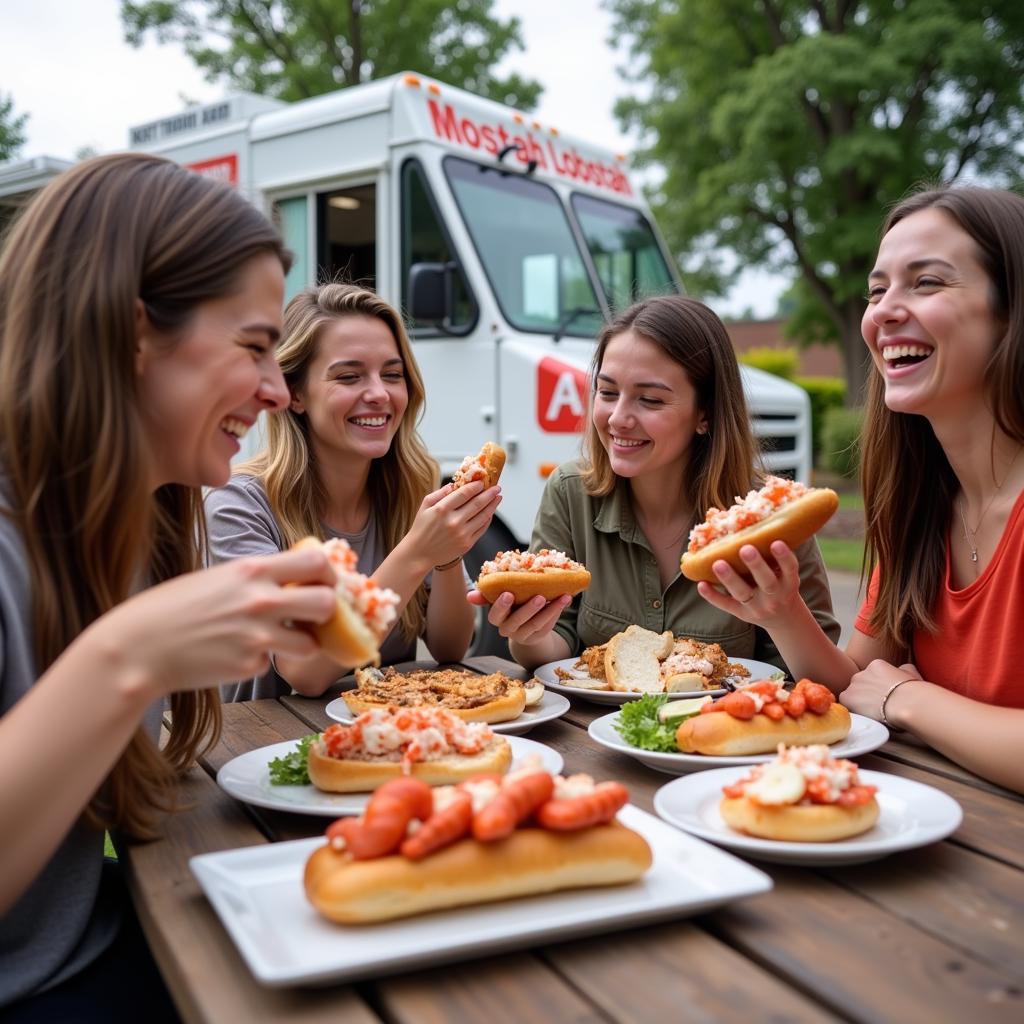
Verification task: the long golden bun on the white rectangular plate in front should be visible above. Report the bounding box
[304,822,651,925]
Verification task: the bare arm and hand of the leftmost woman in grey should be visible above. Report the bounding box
[0,552,334,914]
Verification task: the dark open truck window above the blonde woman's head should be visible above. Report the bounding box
[316,184,377,289]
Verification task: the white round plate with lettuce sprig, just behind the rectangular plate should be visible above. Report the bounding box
[217,736,563,818]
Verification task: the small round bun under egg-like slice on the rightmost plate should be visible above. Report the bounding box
[719,797,879,843]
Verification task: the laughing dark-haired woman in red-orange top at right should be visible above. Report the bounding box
[700,187,1024,792]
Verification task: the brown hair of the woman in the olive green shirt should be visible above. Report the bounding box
[583,295,758,521]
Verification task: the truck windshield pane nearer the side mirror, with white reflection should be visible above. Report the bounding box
[444,157,604,338]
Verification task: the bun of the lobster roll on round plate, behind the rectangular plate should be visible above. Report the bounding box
[309,736,512,793]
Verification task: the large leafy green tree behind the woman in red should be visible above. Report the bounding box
[606,0,1024,402]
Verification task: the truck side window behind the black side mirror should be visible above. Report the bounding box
[401,160,477,334]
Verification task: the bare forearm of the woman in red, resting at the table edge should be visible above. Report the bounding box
[886,679,1024,793]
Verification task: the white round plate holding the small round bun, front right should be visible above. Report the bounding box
[654,768,964,865]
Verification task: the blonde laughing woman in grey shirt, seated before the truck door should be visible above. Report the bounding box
[207,284,501,700]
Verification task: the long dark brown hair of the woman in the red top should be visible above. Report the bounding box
[861,185,1024,651]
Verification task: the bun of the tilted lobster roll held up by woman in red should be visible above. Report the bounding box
[679,478,839,583]
